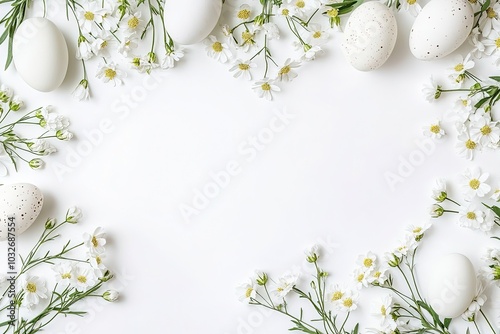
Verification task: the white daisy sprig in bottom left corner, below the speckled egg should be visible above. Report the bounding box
[0,207,119,334]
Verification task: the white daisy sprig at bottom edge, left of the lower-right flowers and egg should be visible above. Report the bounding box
[237,246,359,334]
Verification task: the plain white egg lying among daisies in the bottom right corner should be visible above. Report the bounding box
[426,253,476,318]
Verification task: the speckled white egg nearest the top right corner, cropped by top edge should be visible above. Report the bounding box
[410,0,474,60]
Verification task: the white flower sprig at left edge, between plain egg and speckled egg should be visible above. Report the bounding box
[0,85,73,174]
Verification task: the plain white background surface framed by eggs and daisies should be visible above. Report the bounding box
[0,0,500,334]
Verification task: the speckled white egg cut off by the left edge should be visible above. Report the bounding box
[0,183,43,241]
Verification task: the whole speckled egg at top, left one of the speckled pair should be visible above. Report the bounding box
[342,1,398,71]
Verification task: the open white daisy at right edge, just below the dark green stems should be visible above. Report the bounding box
[470,108,500,148]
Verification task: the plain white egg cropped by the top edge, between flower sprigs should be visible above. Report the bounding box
[164,0,222,44]
